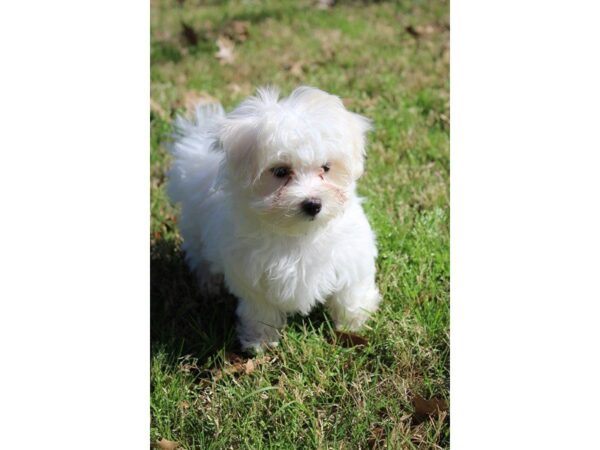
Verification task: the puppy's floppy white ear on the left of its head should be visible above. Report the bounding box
[218,87,279,187]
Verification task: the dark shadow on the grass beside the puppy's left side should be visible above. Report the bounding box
[150,239,239,364]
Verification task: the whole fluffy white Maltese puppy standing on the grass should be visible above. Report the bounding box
[169,87,380,351]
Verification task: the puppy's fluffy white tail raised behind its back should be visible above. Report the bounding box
[167,103,225,209]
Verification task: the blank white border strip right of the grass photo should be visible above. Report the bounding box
[451,0,600,450]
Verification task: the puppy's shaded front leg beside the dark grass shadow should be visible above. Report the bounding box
[236,298,287,352]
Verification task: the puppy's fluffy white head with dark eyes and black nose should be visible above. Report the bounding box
[218,87,371,234]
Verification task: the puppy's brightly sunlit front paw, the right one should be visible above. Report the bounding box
[327,280,381,331]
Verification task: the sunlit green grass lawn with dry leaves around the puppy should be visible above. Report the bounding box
[150,0,449,449]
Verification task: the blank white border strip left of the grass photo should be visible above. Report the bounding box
[0,0,150,449]
